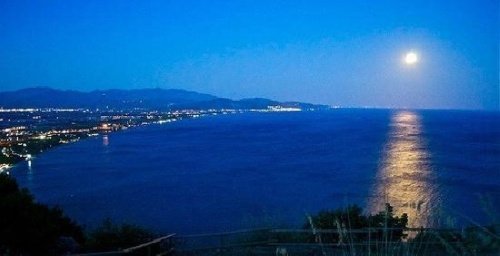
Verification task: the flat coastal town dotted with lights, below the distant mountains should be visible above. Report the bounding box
[0,106,302,172]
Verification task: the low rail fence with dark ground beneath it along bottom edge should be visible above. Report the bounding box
[76,225,500,256]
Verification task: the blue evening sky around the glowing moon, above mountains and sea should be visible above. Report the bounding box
[0,0,500,109]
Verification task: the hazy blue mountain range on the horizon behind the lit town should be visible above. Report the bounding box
[0,87,328,110]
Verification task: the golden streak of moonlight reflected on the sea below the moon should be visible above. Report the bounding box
[369,111,439,227]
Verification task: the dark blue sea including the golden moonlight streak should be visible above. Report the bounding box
[12,110,500,234]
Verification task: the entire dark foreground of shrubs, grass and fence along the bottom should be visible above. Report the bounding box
[0,174,500,255]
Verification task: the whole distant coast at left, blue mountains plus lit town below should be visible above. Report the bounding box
[0,87,329,172]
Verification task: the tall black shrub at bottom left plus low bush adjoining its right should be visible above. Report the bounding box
[0,173,155,255]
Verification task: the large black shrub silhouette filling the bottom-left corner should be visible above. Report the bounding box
[0,173,85,255]
